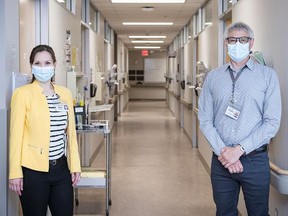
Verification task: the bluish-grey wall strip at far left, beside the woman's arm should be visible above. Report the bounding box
[0,0,19,216]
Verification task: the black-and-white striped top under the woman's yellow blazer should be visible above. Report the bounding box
[46,94,68,160]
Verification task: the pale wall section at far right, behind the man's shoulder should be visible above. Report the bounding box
[232,0,288,215]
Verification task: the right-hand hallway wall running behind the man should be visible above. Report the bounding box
[167,0,288,215]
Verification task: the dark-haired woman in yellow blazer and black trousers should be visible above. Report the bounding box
[9,45,81,216]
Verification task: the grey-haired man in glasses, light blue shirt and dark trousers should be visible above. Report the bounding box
[198,22,281,216]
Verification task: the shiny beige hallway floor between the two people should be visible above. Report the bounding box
[75,101,215,216]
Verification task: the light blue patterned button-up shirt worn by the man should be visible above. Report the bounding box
[198,59,281,155]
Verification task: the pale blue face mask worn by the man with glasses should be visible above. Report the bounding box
[228,41,250,62]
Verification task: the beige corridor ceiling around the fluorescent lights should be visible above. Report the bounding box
[91,0,205,49]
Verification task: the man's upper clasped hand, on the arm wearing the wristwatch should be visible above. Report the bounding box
[218,145,244,168]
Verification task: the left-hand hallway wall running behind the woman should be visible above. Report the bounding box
[0,0,128,216]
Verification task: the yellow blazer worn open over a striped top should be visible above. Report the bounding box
[9,81,81,179]
